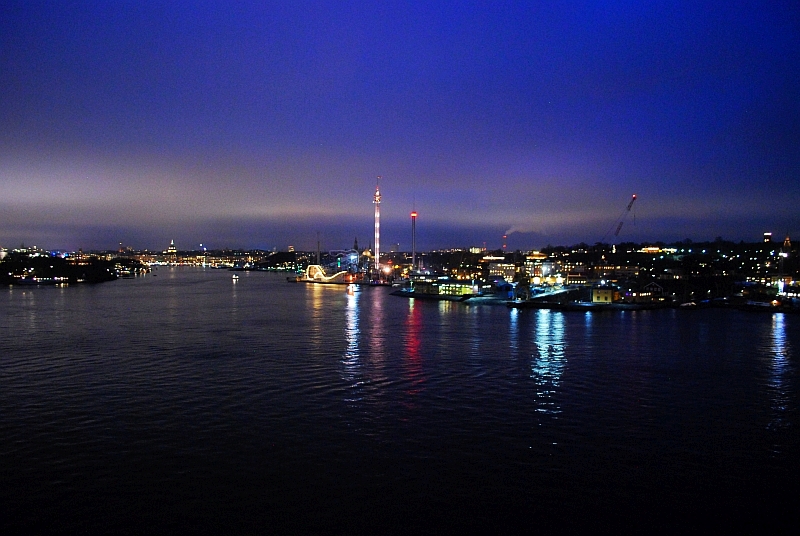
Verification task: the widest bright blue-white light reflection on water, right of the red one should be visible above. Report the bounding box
[531,309,567,415]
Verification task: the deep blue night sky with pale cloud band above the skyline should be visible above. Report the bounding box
[0,0,800,250]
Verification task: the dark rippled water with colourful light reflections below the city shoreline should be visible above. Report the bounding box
[0,268,800,534]
